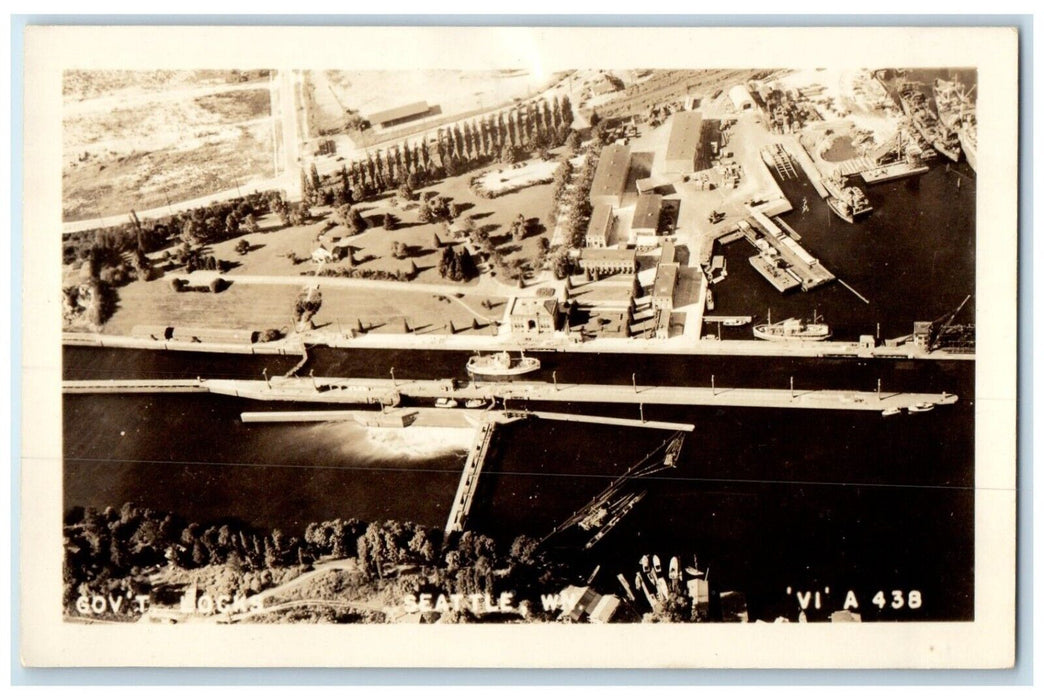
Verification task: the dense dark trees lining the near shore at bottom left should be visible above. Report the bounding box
[63,504,570,626]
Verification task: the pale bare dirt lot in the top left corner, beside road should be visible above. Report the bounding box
[62,71,274,220]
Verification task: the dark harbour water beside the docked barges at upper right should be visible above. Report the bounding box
[705,136,976,341]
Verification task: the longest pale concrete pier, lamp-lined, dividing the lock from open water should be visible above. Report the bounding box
[63,377,957,411]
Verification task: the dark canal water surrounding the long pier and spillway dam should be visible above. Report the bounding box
[64,348,974,620]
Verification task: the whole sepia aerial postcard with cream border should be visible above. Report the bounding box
[22,27,1017,667]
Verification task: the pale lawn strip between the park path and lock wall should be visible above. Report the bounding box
[104,278,505,335]
